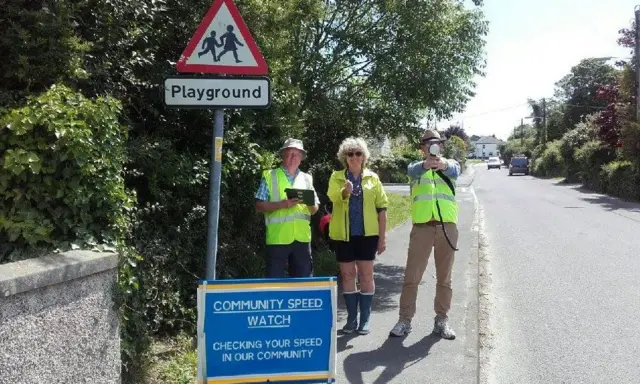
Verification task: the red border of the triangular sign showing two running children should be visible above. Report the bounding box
[176,0,269,76]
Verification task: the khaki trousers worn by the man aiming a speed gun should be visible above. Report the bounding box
[400,222,458,324]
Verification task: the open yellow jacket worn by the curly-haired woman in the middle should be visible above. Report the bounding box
[327,168,389,241]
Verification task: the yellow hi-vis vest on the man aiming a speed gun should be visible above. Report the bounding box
[411,170,458,224]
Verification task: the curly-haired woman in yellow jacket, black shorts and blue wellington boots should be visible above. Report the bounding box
[327,138,388,335]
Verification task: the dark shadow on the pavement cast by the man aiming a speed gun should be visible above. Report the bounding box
[338,334,440,384]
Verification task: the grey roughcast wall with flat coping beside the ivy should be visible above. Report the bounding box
[0,251,120,384]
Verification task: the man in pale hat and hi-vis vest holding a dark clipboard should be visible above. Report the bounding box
[256,139,320,278]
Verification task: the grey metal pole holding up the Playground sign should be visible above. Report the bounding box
[206,109,224,280]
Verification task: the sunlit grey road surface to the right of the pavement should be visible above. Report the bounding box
[473,165,640,384]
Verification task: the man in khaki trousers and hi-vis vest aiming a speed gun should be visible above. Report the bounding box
[390,130,460,340]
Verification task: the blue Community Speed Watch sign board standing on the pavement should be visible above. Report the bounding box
[198,277,337,384]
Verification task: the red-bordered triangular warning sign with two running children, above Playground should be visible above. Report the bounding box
[176,0,269,75]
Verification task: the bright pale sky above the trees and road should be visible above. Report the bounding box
[437,0,640,140]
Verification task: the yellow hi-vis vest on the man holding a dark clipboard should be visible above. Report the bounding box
[263,168,313,245]
